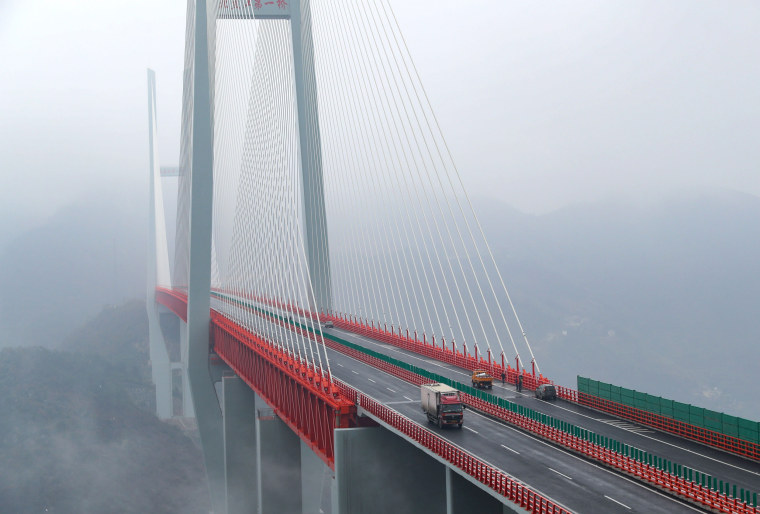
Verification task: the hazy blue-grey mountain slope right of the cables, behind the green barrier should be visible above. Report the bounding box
[479,193,760,419]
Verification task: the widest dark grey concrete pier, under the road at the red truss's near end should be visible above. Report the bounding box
[332,428,452,514]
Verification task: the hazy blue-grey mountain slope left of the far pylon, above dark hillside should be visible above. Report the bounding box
[0,201,145,347]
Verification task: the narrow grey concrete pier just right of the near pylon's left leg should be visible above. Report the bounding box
[222,376,263,514]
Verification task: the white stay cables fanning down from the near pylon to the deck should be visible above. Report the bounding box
[197,0,535,374]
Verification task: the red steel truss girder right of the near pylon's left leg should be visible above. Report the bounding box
[212,311,358,468]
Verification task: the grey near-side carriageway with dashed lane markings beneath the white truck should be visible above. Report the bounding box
[320,333,699,513]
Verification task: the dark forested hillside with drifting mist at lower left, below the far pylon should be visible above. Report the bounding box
[0,302,210,514]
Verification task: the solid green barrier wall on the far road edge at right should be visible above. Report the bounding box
[578,376,760,443]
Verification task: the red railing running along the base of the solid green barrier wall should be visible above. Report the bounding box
[557,386,760,461]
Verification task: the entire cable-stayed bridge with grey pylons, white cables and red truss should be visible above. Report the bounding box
[148,0,760,513]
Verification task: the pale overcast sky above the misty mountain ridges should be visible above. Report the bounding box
[0,0,760,235]
